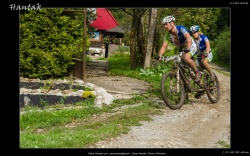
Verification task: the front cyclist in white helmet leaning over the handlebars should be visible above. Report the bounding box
[159,16,201,82]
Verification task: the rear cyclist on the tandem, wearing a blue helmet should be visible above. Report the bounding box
[190,25,215,81]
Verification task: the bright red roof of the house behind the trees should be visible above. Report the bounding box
[90,8,119,30]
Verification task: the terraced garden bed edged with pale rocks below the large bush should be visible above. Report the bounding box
[19,78,114,108]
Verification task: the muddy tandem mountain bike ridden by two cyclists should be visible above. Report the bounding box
[160,51,220,110]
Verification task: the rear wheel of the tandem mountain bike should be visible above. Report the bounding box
[206,73,220,103]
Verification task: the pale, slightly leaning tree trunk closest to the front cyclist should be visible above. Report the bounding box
[144,8,157,69]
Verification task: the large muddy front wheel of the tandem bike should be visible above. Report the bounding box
[160,72,185,109]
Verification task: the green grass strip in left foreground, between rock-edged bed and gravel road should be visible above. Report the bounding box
[20,96,164,148]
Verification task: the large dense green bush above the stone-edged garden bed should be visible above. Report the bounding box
[20,9,90,79]
